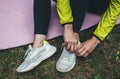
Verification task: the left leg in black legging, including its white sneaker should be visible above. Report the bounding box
[16,0,56,73]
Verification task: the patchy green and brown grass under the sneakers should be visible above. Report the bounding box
[0,25,120,79]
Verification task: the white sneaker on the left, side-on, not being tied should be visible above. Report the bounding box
[16,40,56,73]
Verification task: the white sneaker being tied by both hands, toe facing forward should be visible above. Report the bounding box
[56,42,80,73]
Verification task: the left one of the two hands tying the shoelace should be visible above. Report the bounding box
[64,24,79,52]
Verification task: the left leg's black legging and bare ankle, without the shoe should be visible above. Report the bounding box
[33,0,51,48]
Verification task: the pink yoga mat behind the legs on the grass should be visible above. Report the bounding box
[0,0,120,50]
